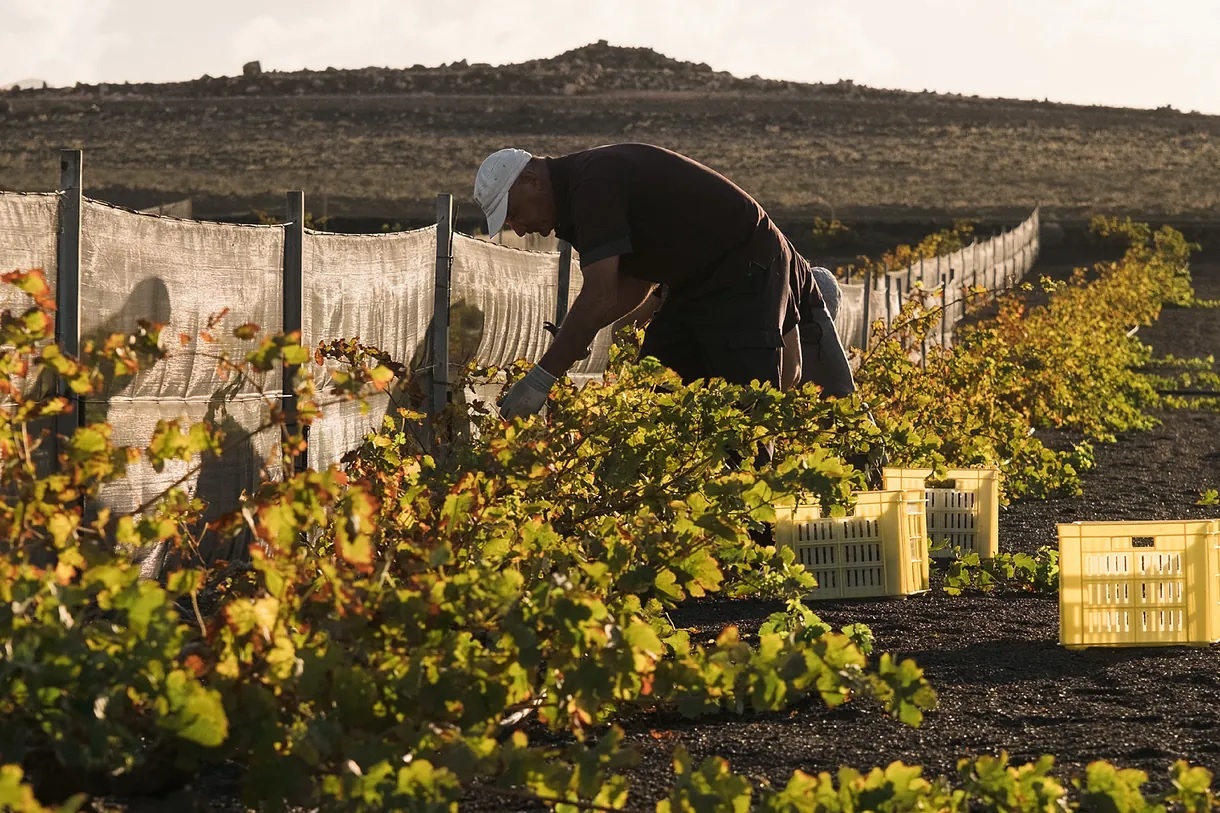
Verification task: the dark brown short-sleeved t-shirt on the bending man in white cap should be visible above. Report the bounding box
[547,144,783,286]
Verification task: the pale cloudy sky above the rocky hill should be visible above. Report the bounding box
[0,0,1220,114]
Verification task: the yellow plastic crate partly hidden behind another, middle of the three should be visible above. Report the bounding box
[882,469,1000,559]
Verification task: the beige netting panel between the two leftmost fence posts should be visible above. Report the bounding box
[81,200,284,570]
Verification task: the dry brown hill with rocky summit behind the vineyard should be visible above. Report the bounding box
[0,42,1220,235]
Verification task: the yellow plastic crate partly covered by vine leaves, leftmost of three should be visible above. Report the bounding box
[775,490,928,599]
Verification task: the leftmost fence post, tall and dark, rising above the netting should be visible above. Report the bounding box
[55,150,84,446]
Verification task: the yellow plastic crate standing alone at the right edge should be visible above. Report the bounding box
[1059,520,1220,648]
